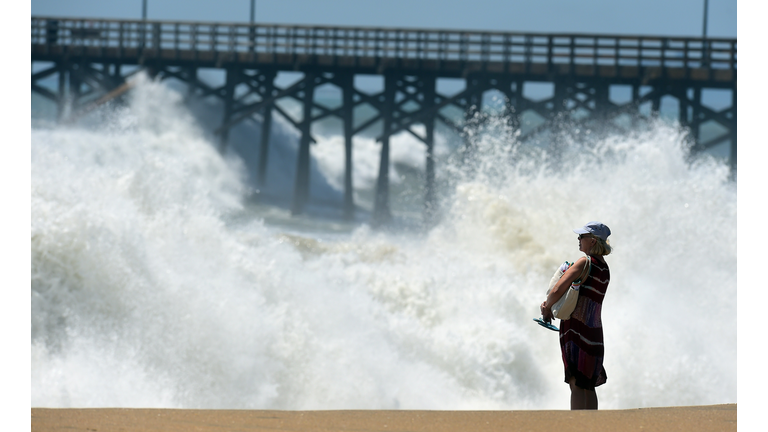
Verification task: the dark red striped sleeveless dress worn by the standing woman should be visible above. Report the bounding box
[560,257,611,390]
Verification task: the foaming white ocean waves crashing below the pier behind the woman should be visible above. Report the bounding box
[31,72,736,410]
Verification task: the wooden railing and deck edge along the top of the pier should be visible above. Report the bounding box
[32,17,736,81]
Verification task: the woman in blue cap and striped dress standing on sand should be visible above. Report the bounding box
[541,222,611,410]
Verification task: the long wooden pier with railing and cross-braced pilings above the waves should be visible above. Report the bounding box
[31,17,737,222]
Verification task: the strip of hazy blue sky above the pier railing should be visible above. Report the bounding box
[31,0,736,38]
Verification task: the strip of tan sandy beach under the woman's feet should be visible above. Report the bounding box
[32,404,736,432]
